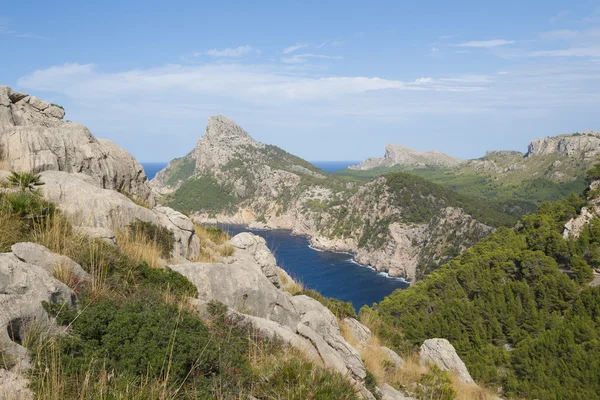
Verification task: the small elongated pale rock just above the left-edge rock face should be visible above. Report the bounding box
[11,242,91,282]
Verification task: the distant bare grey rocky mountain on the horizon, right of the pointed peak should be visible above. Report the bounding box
[348,143,463,171]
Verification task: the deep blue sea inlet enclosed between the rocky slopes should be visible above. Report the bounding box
[220,225,409,311]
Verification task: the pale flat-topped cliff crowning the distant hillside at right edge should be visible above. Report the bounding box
[526,131,600,159]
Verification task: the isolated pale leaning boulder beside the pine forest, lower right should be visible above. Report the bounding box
[420,339,475,384]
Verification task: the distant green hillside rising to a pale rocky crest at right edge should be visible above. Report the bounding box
[337,131,600,217]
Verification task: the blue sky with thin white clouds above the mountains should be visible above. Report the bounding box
[0,0,600,162]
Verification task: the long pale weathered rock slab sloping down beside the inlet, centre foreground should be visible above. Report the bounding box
[170,234,366,390]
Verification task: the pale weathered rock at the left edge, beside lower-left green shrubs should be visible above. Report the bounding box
[0,253,75,370]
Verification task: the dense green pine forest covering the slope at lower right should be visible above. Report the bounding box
[376,176,600,399]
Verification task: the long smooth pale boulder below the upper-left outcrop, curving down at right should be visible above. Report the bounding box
[40,171,200,262]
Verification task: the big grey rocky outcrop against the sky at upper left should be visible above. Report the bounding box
[0,86,155,205]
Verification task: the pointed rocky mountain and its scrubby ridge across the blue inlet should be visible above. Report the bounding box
[151,116,506,281]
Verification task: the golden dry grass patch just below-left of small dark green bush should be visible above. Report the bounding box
[115,228,165,268]
